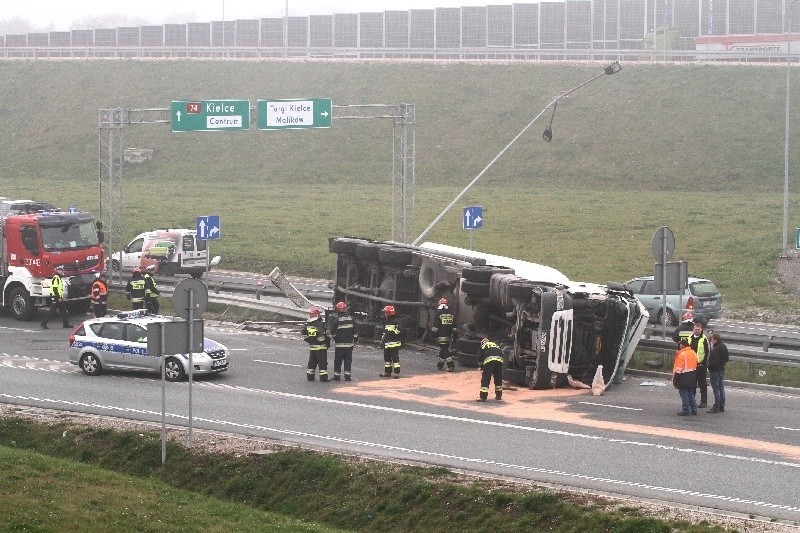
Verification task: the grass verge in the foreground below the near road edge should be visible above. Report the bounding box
[0,418,724,533]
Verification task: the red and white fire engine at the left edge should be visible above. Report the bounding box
[0,197,105,320]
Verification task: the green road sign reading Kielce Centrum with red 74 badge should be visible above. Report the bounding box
[170,100,250,131]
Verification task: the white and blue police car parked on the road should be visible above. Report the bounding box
[69,311,228,381]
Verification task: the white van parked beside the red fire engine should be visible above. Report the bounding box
[111,229,221,278]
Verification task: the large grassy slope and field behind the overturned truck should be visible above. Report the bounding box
[0,61,800,309]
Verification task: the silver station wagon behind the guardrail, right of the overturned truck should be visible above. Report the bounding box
[625,276,722,326]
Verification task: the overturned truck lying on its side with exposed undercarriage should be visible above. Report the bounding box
[329,237,648,389]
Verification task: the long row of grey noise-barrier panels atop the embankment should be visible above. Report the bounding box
[0,0,800,59]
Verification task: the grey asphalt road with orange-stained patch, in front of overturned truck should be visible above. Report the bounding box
[0,310,800,522]
